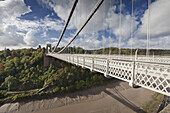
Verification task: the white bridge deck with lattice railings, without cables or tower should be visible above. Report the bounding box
[47,53,170,96]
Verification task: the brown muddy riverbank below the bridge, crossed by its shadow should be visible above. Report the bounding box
[0,82,159,113]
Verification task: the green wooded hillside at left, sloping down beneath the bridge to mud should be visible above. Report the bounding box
[0,47,116,101]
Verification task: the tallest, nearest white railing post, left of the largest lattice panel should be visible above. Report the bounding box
[129,49,138,88]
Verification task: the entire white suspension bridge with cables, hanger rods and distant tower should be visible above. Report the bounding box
[46,0,170,96]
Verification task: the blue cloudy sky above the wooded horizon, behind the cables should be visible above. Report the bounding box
[0,0,170,50]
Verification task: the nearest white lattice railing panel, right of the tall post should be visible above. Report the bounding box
[134,62,170,95]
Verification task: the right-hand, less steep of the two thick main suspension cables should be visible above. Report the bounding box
[57,0,104,53]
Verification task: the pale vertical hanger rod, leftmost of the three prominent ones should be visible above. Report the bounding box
[119,0,122,55]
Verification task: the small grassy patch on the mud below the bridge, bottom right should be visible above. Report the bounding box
[143,93,163,113]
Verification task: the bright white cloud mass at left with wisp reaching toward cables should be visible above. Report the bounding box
[0,0,63,49]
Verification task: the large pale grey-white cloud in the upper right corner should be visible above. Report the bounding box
[138,0,170,38]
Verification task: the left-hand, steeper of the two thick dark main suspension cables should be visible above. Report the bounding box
[52,0,78,52]
